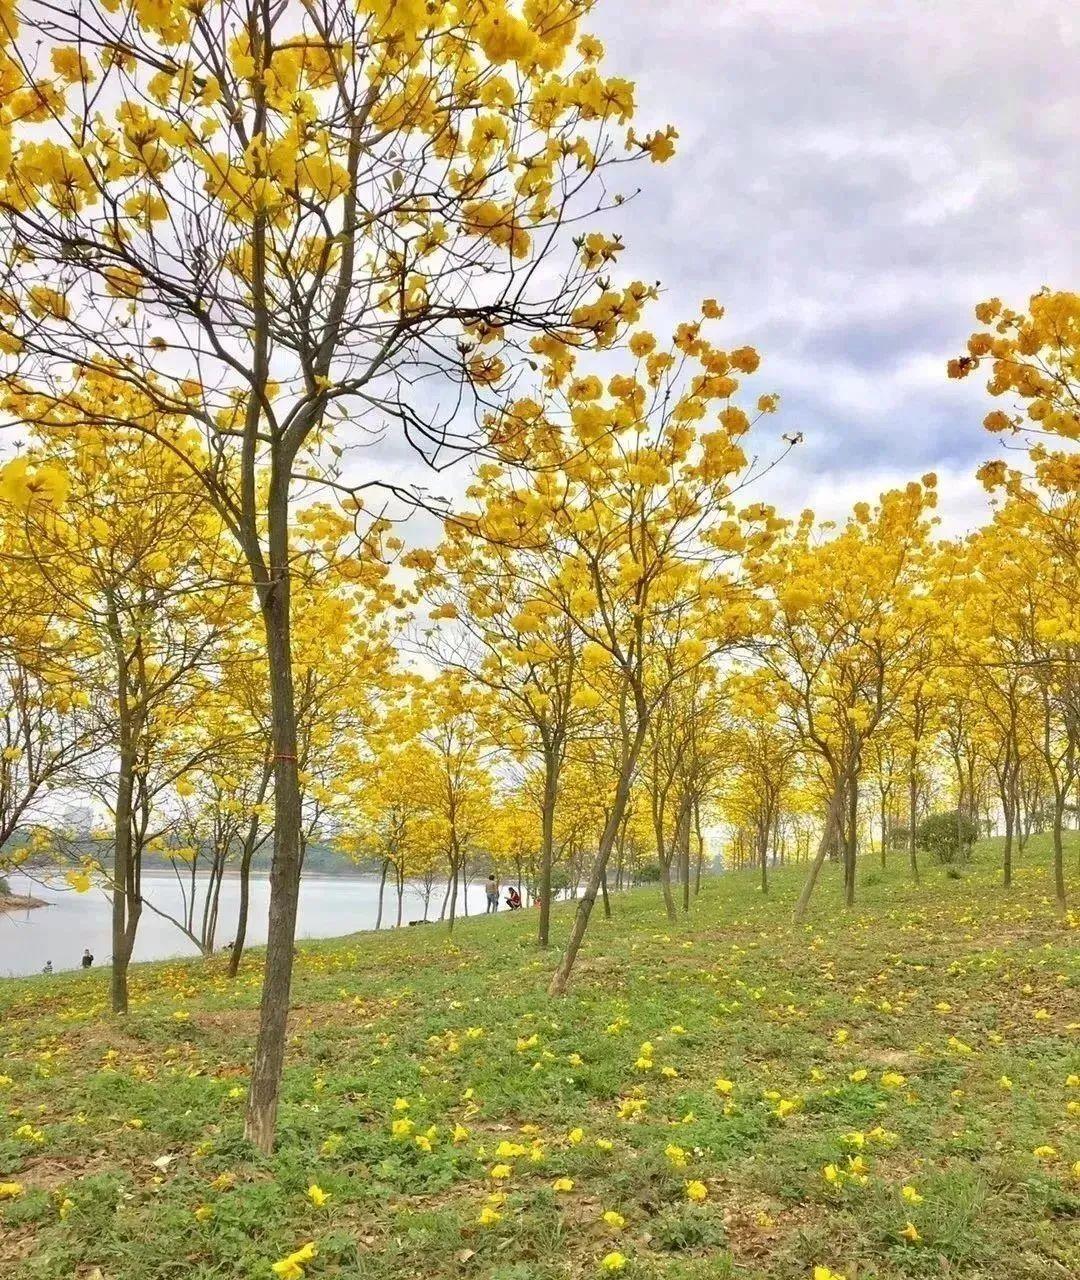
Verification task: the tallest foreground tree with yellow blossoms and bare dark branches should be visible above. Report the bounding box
[0,0,673,1151]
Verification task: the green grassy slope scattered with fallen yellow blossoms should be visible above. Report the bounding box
[0,859,1080,1280]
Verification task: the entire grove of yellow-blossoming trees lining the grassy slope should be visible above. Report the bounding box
[0,0,1076,1151]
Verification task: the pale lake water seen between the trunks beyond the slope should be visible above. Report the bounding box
[0,873,484,978]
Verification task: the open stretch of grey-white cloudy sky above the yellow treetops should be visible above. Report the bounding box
[580,0,1080,531]
